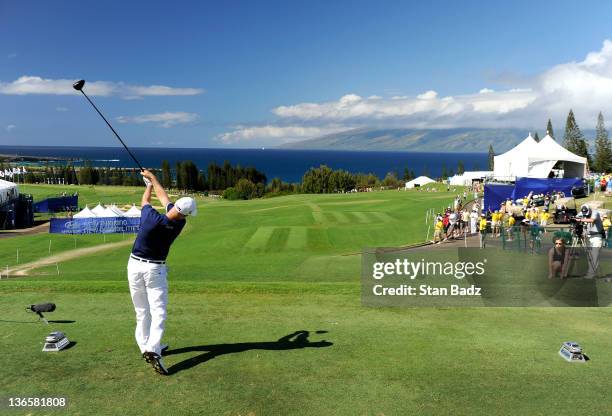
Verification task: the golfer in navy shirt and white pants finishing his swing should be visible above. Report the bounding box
[128,170,197,375]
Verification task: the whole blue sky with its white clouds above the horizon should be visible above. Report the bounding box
[0,0,612,147]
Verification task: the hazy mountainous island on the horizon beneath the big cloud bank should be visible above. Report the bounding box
[279,128,594,154]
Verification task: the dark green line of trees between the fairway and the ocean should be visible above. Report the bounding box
[9,160,464,199]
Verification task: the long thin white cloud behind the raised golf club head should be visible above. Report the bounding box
[0,76,204,99]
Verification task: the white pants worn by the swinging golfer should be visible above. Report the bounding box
[128,257,168,354]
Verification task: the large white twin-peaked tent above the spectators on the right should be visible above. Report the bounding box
[493,134,587,181]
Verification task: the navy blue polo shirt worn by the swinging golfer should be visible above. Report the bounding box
[132,203,186,260]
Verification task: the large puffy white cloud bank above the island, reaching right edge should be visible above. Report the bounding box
[272,40,612,128]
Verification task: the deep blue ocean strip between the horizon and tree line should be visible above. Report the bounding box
[0,146,488,182]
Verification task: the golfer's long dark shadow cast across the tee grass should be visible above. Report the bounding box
[164,331,334,374]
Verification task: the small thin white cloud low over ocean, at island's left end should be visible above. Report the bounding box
[217,125,346,144]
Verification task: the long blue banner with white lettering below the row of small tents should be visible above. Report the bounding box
[49,217,140,234]
